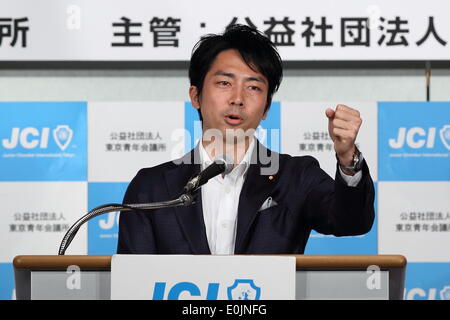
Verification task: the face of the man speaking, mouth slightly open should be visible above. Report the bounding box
[189,49,269,141]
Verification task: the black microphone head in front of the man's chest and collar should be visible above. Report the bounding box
[183,154,234,193]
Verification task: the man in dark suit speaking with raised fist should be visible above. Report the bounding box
[117,26,374,254]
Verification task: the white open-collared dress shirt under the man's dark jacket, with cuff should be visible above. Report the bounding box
[199,139,362,254]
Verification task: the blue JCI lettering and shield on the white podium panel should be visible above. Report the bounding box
[153,279,261,300]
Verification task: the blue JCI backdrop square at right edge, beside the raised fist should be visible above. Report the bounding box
[378,102,450,181]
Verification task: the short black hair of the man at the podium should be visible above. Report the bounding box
[189,24,283,120]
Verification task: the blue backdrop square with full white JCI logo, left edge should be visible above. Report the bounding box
[0,102,87,181]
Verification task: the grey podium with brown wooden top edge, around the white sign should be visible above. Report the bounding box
[13,255,407,300]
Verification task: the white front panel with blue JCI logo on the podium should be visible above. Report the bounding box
[111,255,296,300]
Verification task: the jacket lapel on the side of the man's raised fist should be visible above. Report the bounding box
[234,144,279,254]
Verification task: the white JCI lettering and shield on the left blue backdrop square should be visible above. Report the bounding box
[2,125,73,151]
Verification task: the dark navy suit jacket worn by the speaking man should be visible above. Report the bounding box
[117,142,374,254]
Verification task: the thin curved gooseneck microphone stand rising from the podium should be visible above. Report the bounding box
[58,188,198,255]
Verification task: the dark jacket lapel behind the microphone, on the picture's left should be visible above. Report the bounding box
[165,147,211,254]
